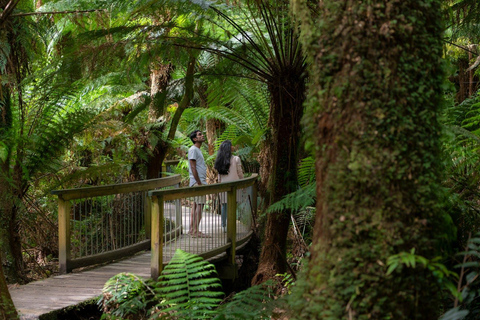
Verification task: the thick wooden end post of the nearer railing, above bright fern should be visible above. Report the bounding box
[151,196,163,280]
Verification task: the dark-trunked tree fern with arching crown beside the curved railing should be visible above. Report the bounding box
[202,0,306,283]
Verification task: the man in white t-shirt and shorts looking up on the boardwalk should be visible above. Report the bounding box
[188,130,208,237]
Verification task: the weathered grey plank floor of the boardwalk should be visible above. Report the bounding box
[10,214,249,320]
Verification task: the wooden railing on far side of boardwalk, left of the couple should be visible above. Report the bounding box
[52,175,181,273]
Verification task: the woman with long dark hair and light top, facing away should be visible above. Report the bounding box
[214,140,243,232]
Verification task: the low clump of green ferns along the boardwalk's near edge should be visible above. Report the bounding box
[98,250,278,320]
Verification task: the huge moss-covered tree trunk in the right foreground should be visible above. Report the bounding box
[291,0,445,320]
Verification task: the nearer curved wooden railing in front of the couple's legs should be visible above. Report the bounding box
[148,174,257,279]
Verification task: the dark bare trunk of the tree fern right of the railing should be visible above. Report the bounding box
[252,68,305,285]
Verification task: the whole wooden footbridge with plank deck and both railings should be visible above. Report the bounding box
[10,175,257,319]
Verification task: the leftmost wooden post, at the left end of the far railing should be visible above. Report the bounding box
[58,196,71,274]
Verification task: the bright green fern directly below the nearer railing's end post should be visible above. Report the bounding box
[155,249,223,319]
